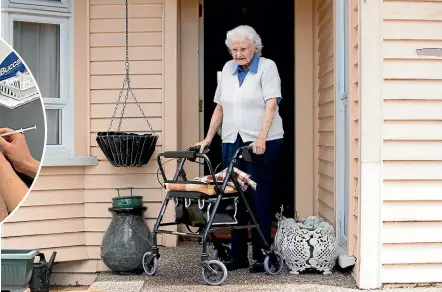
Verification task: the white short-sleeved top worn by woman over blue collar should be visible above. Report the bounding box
[214,57,284,143]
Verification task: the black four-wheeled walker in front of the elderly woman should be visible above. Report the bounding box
[142,146,284,286]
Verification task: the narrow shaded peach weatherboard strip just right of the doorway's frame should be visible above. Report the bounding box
[314,0,336,225]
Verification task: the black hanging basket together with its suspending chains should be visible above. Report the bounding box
[96,0,158,167]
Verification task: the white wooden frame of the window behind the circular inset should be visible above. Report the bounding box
[2,0,74,158]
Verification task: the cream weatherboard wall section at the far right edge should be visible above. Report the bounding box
[381,1,442,283]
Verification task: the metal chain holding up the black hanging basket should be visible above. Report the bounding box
[108,0,153,134]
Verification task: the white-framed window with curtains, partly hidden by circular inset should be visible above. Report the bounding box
[2,0,74,156]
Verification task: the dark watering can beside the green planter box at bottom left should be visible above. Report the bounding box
[29,251,57,292]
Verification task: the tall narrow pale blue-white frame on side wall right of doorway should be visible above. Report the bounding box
[334,0,350,253]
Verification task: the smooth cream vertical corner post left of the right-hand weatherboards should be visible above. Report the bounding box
[357,1,384,289]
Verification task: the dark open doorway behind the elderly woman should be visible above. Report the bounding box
[200,0,296,218]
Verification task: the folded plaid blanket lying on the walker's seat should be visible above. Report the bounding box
[165,168,256,196]
